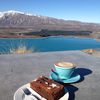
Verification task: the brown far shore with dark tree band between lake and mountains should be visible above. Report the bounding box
[0,28,100,40]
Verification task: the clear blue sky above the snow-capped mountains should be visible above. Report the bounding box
[0,0,100,23]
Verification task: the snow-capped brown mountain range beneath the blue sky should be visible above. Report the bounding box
[0,11,100,31]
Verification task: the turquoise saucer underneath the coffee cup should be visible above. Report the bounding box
[50,72,81,83]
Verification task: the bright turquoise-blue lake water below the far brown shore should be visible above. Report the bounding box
[0,36,100,54]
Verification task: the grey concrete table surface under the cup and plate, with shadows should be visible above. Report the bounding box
[0,51,100,100]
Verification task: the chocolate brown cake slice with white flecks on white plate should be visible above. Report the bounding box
[30,76,64,100]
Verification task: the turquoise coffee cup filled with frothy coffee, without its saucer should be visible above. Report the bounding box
[54,62,75,79]
